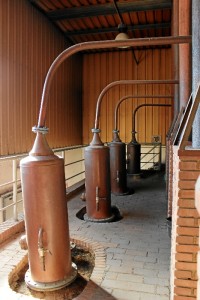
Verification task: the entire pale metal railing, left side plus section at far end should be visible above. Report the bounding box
[0,143,161,224]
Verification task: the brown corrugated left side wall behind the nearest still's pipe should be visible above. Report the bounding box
[0,0,82,155]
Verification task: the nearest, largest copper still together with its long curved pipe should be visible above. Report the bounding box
[20,36,188,291]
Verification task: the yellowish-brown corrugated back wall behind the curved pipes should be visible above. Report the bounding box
[83,48,173,145]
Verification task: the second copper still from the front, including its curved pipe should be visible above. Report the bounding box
[85,80,178,222]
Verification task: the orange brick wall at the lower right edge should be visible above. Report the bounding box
[172,150,200,300]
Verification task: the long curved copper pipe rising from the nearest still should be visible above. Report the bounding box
[36,36,191,129]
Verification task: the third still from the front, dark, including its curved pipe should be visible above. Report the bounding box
[108,95,170,195]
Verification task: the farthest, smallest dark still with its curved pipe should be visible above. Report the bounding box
[127,103,171,176]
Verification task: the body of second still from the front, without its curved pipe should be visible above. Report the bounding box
[84,129,114,222]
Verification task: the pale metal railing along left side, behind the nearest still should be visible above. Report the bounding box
[0,145,85,224]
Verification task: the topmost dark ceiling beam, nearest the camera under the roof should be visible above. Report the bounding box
[43,0,172,21]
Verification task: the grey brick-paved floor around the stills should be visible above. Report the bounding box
[0,174,170,300]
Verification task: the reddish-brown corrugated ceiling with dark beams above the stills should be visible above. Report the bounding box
[29,0,172,49]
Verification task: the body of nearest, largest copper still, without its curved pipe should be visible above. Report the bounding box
[20,128,77,291]
